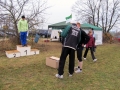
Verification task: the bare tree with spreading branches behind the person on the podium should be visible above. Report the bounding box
[0,0,49,43]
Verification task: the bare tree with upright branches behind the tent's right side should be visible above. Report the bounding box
[72,0,120,33]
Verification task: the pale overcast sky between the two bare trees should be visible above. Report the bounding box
[43,0,76,29]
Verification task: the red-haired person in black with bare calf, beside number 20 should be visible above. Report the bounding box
[75,22,90,73]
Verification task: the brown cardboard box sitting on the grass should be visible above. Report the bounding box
[46,56,60,68]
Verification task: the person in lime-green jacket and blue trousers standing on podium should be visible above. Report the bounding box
[18,15,28,47]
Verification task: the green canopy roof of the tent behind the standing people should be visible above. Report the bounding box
[48,21,102,30]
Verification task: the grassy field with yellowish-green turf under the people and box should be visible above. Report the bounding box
[0,42,120,90]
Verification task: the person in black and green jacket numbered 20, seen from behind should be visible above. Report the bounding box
[56,23,80,78]
